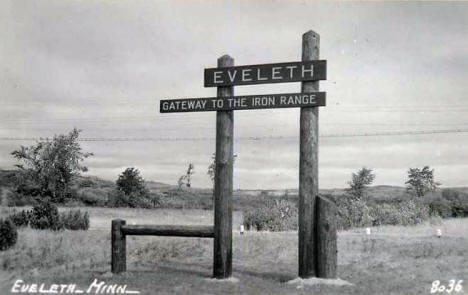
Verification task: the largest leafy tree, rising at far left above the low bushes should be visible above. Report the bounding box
[11,128,93,202]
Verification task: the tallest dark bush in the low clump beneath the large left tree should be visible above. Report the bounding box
[29,202,63,230]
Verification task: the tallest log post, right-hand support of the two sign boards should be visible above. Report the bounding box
[299,31,320,278]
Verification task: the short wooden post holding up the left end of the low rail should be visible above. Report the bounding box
[111,219,127,273]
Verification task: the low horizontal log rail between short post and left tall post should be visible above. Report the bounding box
[121,225,214,238]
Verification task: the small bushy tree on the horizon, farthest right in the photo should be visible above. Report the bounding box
[405,166,440,198]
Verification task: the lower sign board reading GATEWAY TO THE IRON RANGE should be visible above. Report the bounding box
[159,92,326,113]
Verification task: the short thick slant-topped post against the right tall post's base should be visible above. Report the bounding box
[315,196,338,279]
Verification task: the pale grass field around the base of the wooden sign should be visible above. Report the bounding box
[0,207,468,294]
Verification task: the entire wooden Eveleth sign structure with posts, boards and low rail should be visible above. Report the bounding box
[154,31,337,279]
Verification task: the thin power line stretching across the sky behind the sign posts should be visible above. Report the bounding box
[0,129,468,142]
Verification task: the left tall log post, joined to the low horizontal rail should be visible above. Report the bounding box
[213,55,234,279]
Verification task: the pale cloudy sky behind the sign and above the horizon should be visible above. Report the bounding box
[0,0,468,189]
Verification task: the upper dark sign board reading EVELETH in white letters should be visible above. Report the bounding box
[205,60,327,87]
